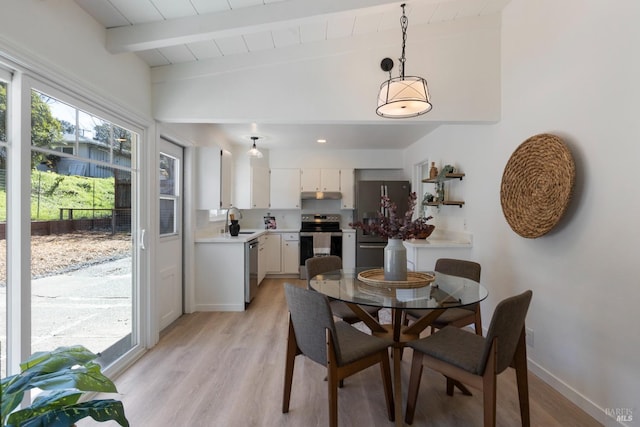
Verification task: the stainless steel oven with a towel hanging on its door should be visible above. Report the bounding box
[300,214,342,279]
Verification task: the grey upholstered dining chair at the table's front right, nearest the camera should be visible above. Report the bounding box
[405,290,533,427]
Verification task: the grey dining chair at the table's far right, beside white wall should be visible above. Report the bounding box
[405,258,482,335]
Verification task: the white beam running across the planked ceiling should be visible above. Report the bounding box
[106,0,398,53]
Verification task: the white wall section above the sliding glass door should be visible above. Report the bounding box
[0,0,151,119]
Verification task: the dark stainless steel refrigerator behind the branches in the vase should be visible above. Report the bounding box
[354,181,411,267]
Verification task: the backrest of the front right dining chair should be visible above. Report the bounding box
[480,290,533,374]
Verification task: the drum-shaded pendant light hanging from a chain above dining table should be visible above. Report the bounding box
[376,3,433,119]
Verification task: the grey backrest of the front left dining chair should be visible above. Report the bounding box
[284,283,340,366]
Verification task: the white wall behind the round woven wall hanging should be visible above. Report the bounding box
[405,0,640,425]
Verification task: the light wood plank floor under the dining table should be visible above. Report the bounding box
[85,279,601,427]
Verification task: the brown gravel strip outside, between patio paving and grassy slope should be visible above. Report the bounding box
[0,232,131,285]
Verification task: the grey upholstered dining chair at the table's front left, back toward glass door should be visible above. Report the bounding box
[282,283,394,427]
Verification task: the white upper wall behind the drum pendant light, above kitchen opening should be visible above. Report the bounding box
[152,15,500,123]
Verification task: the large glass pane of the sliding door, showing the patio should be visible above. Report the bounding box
[31,90,139,363]
